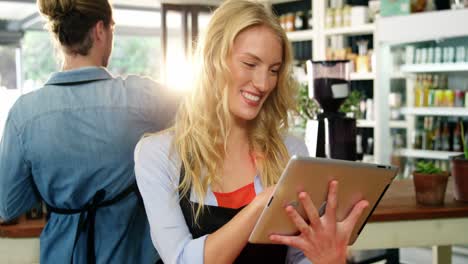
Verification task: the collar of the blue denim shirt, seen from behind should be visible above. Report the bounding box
[46,67,113,85]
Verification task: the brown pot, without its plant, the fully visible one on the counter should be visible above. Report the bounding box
[413,172,449,205]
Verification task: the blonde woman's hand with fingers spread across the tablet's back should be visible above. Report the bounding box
[270,181,369,264]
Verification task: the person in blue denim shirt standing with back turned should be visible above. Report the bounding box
[0,0,176,264]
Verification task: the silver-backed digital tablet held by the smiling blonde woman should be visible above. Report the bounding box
[249,156,398,245]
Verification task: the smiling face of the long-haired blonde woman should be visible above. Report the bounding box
[228,26,283,122]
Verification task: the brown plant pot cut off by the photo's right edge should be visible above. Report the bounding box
[451,155,468,202]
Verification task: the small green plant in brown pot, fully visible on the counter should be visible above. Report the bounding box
[413,161,449,205]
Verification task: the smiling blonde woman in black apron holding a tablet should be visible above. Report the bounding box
[135,0,367,263]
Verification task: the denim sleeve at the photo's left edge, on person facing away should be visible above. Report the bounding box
[0,115,38,220]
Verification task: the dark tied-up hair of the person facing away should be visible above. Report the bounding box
[37,0,112,56]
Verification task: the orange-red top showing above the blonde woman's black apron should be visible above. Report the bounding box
[213,182,256,209]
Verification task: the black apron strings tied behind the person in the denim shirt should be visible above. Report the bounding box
[46,183,142,264]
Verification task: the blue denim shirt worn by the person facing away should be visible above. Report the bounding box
[0,67,177,263]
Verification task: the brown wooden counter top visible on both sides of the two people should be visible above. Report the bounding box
[0,180,468,238]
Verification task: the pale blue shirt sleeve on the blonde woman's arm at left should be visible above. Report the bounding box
[135,134,206,264]
